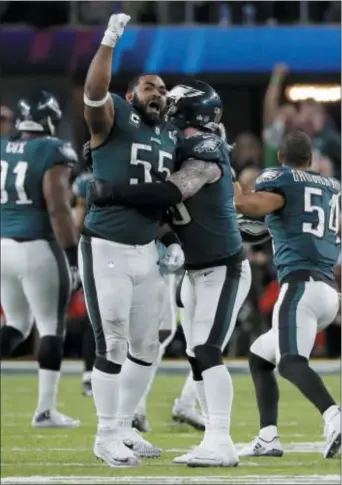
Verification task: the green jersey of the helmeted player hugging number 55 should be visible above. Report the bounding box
[172,133,243,267]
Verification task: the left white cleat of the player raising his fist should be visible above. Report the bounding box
[94,437,140,468]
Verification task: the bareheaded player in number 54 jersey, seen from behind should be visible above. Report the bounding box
[235,131,341,458]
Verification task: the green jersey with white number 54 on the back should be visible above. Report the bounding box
[255,167,341,281]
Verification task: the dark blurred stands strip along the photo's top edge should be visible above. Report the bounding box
[0,0,341,28]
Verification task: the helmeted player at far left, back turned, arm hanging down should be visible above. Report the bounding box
[0,91,79,428]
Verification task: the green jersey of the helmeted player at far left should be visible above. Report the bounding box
[1,136,77,240]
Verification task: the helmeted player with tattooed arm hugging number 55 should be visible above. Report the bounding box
[88,81,251,467]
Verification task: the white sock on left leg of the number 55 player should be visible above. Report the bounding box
[91,367,120,433]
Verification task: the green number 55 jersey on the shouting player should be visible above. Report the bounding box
[85,95,179,245]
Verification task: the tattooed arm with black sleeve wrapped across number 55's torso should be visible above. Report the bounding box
[88,160,222,208]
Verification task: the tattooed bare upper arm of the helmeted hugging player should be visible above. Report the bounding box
[168,160,221,200]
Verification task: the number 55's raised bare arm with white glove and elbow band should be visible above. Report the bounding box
[84,13,130,147]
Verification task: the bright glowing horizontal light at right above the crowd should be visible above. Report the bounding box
[285,84,341,103]
